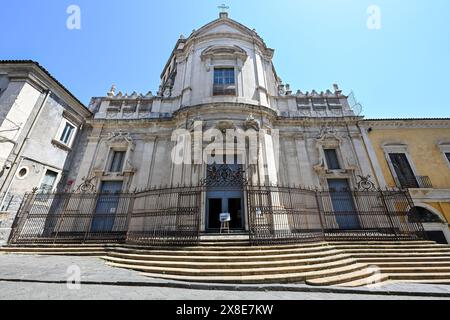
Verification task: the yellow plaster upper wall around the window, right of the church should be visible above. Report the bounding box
[368,126,450,189]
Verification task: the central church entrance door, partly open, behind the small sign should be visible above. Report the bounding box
[206,191,244,231]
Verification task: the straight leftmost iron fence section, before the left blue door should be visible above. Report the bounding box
[10,193,133,243]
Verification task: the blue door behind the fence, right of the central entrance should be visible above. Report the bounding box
[328,179,360,230]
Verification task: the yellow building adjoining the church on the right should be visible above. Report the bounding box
[362,119,450,243]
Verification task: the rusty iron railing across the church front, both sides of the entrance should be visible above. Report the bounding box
[9,184,424,246]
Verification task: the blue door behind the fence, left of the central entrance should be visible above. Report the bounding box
[91,181,123,232]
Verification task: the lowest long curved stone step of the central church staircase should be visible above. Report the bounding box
[125,264,365,283]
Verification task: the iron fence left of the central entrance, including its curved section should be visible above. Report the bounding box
[9,187,201,245]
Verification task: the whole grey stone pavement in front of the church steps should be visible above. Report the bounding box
[0,254,450,300]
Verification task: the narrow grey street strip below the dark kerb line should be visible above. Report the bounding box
[0,282,446,301]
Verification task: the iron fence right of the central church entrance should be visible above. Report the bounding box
[247,186,425,244]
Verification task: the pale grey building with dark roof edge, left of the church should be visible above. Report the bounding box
[0,61,91,242]
